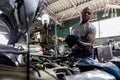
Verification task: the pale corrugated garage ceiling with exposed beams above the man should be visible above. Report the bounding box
[30,0,120,31]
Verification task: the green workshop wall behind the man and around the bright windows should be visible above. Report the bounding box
[40,9,120,44]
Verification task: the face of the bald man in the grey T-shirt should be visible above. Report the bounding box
[82,9,92,22]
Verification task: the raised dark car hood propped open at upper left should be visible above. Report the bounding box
[0,0,43,44]
